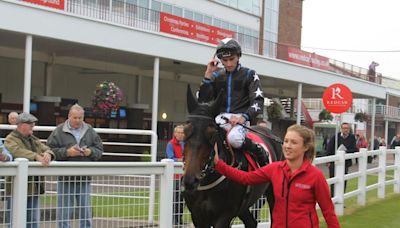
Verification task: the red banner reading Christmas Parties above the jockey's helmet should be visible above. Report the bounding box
[160,12,234,44]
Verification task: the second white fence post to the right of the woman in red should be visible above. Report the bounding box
[357,148,368,206]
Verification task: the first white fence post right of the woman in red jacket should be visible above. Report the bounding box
[335,150,345,215]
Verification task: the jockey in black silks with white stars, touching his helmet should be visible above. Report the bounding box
[198,38,267,166]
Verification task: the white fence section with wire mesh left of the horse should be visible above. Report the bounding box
[1,158,175,228]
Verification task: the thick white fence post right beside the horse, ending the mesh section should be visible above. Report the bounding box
[160,159,174,228]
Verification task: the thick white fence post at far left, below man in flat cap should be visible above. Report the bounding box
[12,158,28,228]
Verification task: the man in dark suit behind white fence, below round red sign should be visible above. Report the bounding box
[327,123,357,197]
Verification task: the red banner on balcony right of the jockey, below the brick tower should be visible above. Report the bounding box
[288,47,330,70]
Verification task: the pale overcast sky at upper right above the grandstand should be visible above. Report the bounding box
[301,0,400,80]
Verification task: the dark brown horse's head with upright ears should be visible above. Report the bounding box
[183,86,222,191]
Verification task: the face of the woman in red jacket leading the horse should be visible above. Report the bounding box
[283,131,308,161]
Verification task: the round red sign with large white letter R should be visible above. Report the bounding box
[322,83,353,113]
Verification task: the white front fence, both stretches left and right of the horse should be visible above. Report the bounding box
[0,147,400,228]
